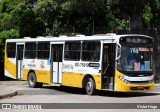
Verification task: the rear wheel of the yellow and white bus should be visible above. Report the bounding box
[28,72,43,88]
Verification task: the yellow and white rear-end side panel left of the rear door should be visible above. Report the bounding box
[4,55,16,79]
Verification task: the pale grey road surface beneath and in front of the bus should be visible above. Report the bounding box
[0,80,160,112]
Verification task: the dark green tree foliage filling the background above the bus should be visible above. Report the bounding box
[0,0,160,38]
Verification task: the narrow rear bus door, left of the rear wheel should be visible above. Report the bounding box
[16,44,24,79]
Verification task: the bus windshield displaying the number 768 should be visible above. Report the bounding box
[117,45,153,71]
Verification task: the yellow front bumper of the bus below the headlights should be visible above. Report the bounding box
[115,70,154,92]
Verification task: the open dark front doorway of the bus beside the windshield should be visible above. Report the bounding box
[102,44,115,90]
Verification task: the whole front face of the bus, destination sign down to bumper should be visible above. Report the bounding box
[114,36,154,92]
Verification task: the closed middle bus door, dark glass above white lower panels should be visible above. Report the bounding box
[51,44,63,83]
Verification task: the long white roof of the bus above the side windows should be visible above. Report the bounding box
[6,34,151,42]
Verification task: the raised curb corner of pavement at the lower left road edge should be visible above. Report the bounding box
[0,90,17,100]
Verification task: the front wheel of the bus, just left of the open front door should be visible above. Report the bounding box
[86,77,96,95]
